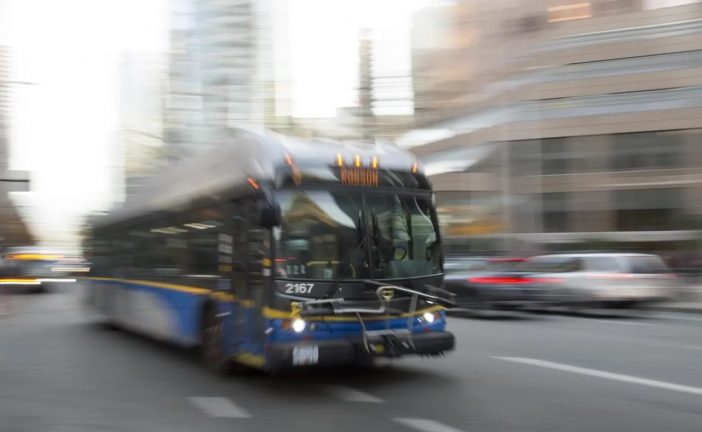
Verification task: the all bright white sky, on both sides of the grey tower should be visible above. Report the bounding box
[0,0,429,245]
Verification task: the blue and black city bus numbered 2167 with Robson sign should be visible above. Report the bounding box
[88,130,454,372]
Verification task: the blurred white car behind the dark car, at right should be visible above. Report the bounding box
[520,253,678,308]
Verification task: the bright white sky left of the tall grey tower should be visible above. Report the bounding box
[0,0,165,244]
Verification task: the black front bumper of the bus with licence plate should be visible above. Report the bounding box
[267,331,456,370]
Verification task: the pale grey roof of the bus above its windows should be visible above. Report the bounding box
[94,128,416,230]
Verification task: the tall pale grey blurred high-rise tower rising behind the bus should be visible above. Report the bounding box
[166,0,274,157]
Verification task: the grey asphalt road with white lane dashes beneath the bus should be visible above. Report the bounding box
[0,285,702,432]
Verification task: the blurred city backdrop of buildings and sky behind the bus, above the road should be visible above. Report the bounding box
[0,0,702,272]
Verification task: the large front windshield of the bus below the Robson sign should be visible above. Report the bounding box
[275,189,441,280]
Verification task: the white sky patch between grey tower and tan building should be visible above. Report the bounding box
[283,0,429,117]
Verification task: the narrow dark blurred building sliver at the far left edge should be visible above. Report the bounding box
[0,46,34,248]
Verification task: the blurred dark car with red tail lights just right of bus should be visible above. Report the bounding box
[444,258,544,310]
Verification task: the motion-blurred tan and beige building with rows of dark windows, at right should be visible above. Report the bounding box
[408,0,702,255]
